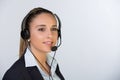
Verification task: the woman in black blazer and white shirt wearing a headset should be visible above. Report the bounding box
[3,7,65,80]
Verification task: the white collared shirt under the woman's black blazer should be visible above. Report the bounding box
[25,48,60,80]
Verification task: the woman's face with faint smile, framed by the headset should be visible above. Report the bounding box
[30,13,58,53]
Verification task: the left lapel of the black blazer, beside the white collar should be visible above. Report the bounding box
[19,55,44,80]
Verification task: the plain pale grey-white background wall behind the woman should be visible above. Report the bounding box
[0,0,120,80]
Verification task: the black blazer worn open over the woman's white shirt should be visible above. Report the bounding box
[2,55,65,80]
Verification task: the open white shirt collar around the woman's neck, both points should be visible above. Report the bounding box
[25,48,58,75]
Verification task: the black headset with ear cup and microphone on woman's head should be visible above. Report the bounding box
[21,8,62,51]
